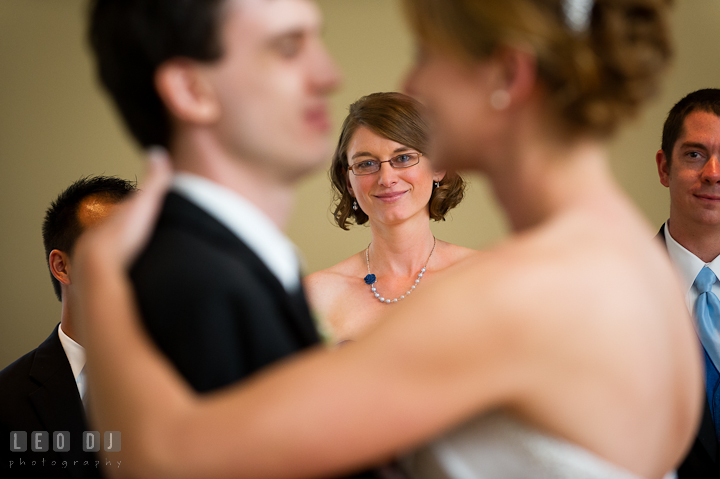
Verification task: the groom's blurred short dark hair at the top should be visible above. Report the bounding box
[89,0,226,148]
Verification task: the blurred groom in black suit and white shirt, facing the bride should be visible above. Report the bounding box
[90,0,374,476]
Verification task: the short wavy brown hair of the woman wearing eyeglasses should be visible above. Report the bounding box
[330,92,465,230]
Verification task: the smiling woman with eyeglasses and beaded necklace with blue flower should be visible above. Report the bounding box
[305,93,474,342]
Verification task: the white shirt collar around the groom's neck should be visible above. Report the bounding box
[173,173,300,292]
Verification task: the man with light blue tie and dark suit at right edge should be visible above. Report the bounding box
[656,89,720,479]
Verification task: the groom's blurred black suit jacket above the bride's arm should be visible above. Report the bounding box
[131,193,371,477]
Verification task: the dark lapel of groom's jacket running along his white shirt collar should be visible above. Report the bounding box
[160,193,319,346]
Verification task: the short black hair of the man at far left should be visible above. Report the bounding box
[42,176,136,301]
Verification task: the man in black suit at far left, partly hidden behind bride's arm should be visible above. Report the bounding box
[0,176,135,478]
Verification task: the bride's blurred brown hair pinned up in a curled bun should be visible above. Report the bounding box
[404,0,671,137]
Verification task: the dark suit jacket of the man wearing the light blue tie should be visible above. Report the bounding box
[655,225,720,479]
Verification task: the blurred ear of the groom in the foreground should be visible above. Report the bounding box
[155,58,221,124]
